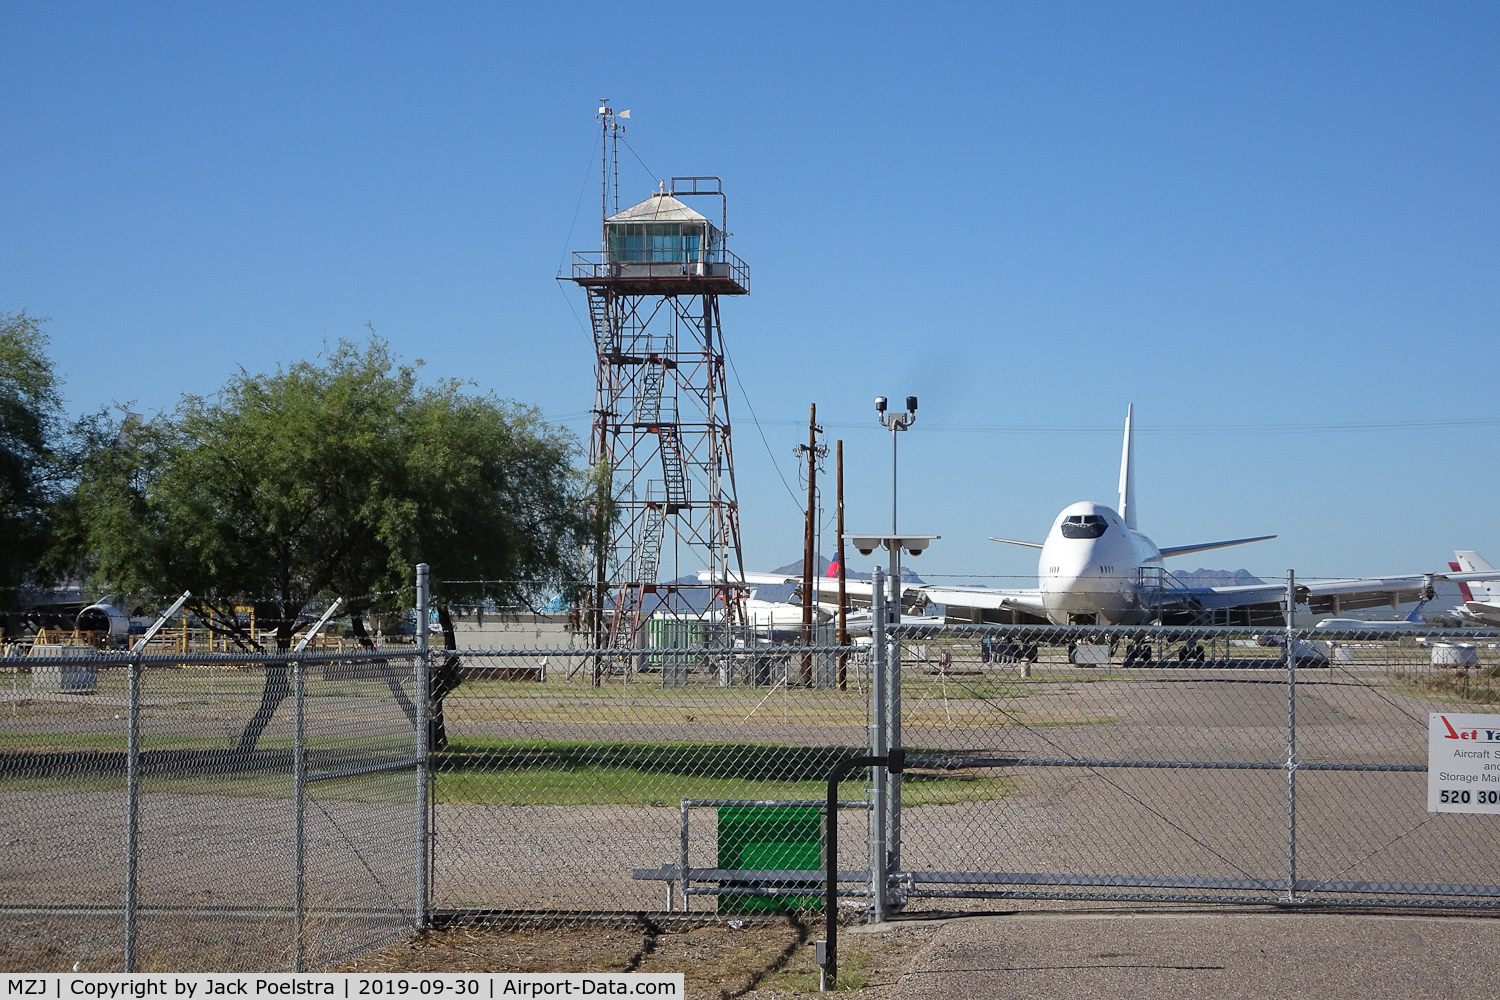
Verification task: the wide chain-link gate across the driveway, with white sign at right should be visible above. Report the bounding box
[890,625,1500,907]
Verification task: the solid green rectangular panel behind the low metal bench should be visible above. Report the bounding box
[717,805,824,913]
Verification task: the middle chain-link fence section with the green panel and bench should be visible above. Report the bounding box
[432,645,870,922]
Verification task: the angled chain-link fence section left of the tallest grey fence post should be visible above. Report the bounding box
[0,648,422,972]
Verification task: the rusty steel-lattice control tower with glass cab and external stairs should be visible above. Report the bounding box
[572,102,750,649]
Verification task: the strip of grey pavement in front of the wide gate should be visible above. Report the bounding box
[870,910,1500,1000]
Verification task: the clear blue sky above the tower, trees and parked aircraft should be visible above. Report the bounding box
[0,0,1500,583]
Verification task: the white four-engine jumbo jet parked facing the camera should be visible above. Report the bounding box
[711,406,1500,625]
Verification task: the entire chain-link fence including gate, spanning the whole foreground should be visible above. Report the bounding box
[0,569,1500,970]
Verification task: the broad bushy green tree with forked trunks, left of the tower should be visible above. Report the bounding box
[75,339,587,750]
